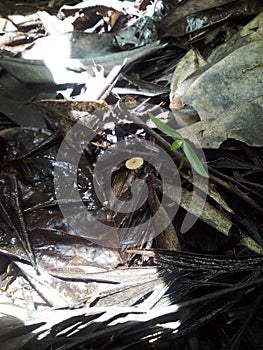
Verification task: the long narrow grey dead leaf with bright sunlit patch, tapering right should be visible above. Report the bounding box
[0,42,164,85]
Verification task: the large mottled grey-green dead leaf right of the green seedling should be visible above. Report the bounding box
[170,40,263,148]
